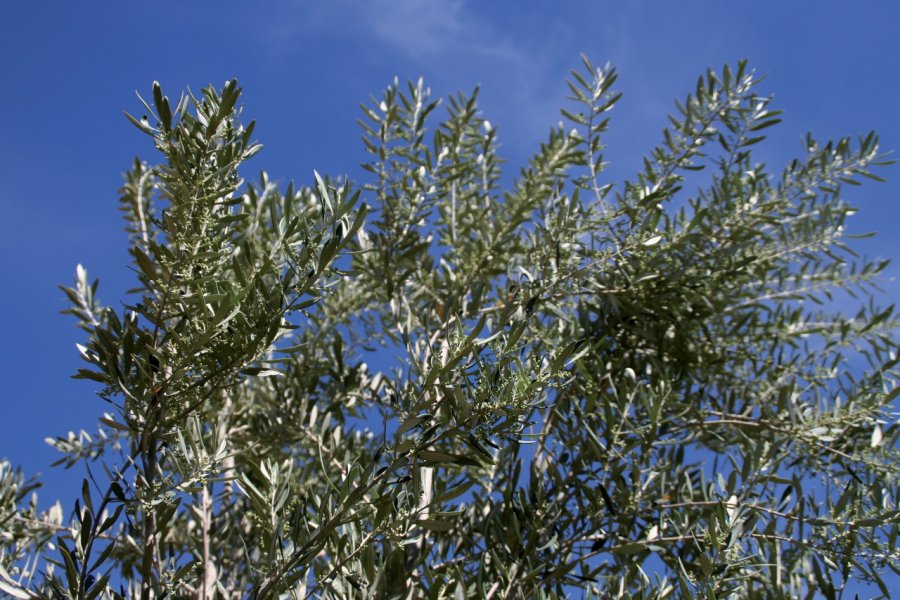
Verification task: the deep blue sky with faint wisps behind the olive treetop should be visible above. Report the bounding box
[0,0,900,592]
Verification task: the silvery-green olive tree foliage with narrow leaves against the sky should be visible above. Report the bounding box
[0,59,900,598]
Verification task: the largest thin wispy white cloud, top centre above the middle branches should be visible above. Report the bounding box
[267,0,577,155]
